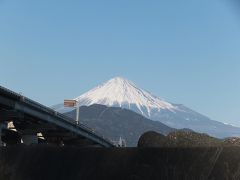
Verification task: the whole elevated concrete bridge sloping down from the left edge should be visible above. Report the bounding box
[0,86,114,147]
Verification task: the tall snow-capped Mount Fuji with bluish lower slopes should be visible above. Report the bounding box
[52,77,240,138]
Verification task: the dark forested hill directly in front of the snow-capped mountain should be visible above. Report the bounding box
[63,104,174,146]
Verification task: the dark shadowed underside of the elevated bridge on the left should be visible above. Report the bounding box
[0,107,102,147]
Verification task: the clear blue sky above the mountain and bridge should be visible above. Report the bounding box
[0,0,240,125]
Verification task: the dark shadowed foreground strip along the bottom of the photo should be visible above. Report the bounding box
[0,146,240,180]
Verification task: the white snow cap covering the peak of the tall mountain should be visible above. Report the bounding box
[75,77,177,117]
